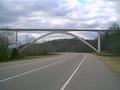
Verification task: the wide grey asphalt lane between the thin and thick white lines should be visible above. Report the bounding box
[0,54,84,90]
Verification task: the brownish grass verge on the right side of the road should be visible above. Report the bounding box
[97,53,120,75]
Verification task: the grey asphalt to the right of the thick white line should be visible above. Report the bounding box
[65,54,120,90]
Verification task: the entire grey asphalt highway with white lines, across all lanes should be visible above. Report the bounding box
[0,53,120,90]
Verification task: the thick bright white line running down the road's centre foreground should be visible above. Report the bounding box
[60,56,86,90]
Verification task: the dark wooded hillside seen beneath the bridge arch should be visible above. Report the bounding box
[24,38,97,55]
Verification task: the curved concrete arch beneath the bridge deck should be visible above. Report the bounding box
[20,31,99,53]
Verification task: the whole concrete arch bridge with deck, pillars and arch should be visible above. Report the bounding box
[0,29,112,53]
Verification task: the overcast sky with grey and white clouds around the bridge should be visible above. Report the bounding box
[0,0,120,42]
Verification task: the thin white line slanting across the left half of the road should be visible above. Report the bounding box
[0,55,75,83]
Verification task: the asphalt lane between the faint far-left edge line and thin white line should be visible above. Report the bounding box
[0,53,77,80]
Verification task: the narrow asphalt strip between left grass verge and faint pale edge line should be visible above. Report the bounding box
[0,53,71,69]
